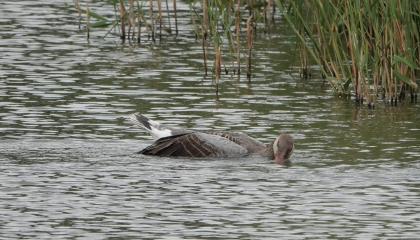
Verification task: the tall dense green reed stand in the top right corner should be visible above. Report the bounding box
[277,0,420,106]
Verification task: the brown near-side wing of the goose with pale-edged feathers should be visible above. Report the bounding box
[139,132,248,157]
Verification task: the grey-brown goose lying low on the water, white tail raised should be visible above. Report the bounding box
[129,113,294,164]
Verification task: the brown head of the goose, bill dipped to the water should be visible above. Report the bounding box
[272,133,295,165]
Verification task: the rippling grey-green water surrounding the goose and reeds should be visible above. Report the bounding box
[0,1,420,239]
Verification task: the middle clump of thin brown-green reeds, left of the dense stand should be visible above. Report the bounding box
[190,0,275,81]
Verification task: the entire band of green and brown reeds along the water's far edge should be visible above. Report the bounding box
[74,0,420,108]
